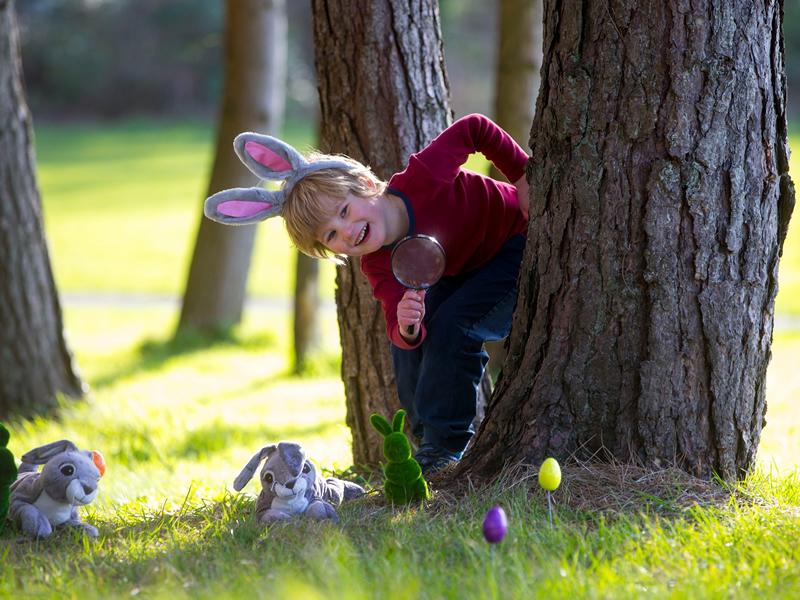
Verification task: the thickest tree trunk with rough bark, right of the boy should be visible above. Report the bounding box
[459,0,794,478]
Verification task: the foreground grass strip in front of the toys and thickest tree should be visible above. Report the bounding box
[0,472,800,599]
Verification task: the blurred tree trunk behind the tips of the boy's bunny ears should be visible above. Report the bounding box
[178,0,287,331]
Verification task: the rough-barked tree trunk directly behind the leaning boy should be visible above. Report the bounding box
[312,0,451,464]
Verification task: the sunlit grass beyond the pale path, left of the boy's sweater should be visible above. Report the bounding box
[36,116,334,298]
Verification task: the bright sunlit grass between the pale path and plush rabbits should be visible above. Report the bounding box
[4,304,351,514]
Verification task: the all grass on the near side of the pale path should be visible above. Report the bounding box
[0,307,800,600]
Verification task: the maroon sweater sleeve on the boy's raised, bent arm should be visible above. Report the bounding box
[412,114,528,183]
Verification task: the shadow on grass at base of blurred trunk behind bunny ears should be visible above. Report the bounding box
[90,326,275,390]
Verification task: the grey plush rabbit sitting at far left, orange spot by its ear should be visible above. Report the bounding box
[8,440,105,538]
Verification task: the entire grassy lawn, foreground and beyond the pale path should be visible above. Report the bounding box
[0,122,800,600]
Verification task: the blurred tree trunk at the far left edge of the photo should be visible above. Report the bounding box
[0,0,83,418]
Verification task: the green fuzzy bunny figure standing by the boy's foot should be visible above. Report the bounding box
[369,409,431,504]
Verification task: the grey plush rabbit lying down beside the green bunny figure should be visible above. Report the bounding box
[233,442,364,525]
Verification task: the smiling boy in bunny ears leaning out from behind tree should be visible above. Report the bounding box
[206,114,528,474]
